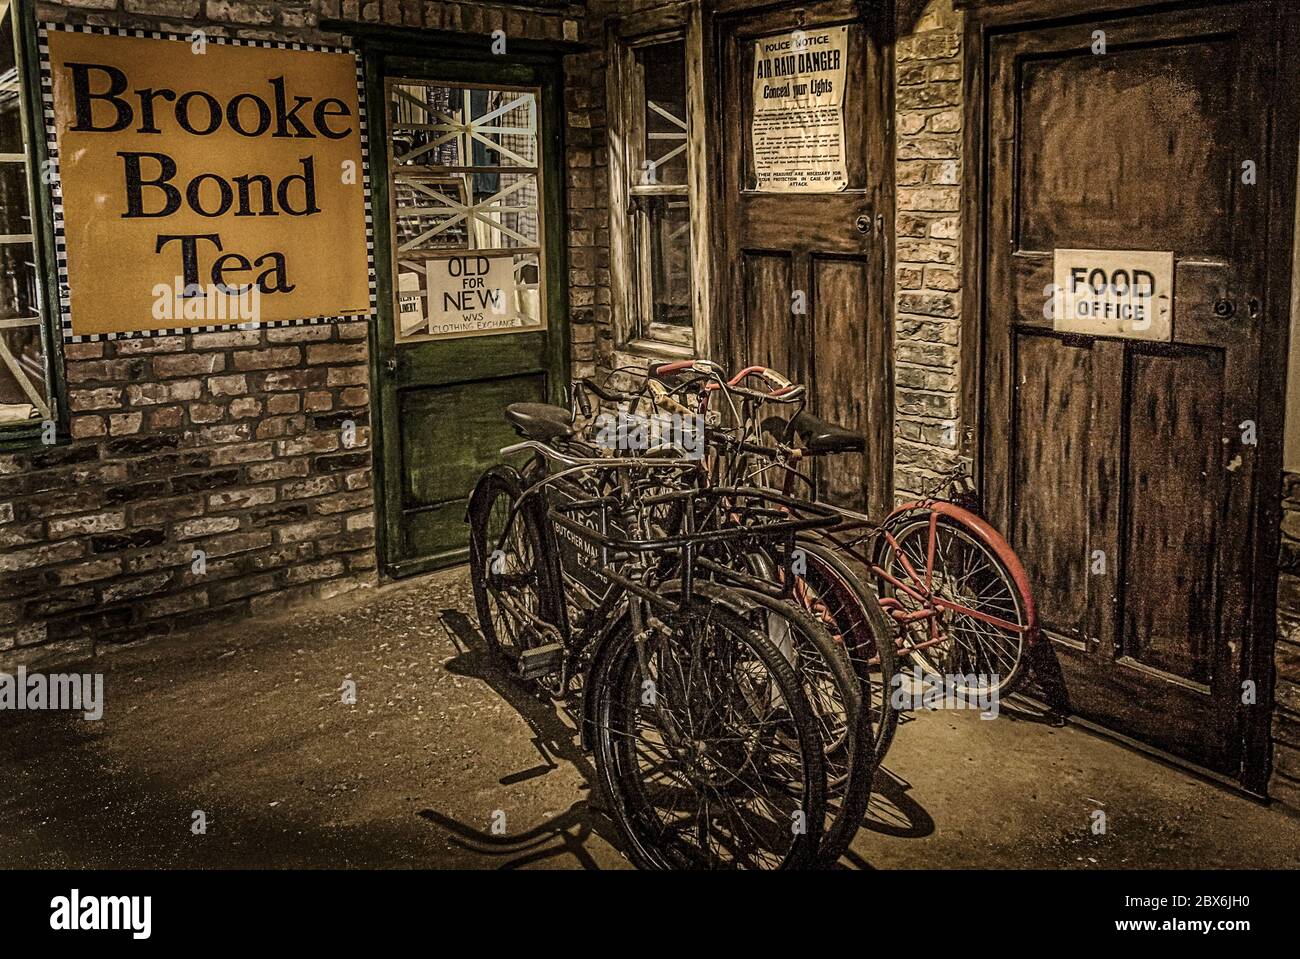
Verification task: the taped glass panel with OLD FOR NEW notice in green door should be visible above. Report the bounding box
[387,79,546,342]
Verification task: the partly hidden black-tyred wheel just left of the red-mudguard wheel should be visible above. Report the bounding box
[794,539,898,765]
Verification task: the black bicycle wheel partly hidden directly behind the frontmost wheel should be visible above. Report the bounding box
[733,589,876,865]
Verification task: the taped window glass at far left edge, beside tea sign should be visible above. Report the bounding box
[0,0,49,426]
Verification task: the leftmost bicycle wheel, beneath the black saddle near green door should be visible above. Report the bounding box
[469,467,562,685]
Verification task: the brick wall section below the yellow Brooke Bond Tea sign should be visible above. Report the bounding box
[0,321,374,664]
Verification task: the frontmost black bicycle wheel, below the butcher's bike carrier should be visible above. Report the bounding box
[588,595,826,869]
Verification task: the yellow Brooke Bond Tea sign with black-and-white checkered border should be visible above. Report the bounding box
[42,25,372,339]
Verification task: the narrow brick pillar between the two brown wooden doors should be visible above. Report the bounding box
[894,0,962,499]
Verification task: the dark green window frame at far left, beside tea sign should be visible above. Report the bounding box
[0,0,70,452]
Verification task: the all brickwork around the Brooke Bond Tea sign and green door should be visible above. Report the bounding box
[0,0,587,671]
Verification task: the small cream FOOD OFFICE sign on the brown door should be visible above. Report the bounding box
[1052,249,1174,342]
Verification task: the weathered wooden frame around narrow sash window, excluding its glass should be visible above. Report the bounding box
[606,0,711,357]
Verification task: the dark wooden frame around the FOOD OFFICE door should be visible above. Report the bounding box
[954,0,1300,797]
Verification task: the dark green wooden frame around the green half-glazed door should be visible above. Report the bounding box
[352,29,585,580]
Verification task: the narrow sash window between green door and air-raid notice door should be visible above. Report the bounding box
[610,30,705,355]
